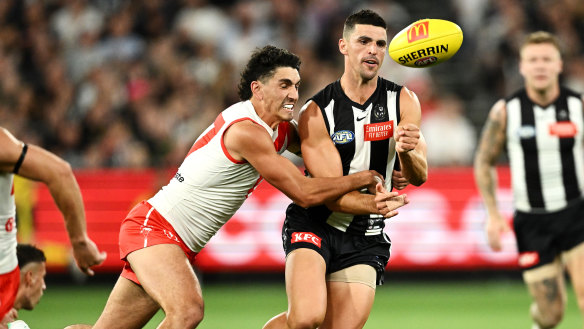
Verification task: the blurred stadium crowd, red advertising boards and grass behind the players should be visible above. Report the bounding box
[0,0,584,329]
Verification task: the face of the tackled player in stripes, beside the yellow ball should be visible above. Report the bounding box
[341,24,387,81]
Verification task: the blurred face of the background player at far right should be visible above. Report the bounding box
[519,43,562,91]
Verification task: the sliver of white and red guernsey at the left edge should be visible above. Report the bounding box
[0,173,18,274]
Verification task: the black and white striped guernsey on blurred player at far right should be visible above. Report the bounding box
[506,88,584,213]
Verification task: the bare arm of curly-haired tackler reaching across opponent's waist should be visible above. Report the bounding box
[223,121,381,207]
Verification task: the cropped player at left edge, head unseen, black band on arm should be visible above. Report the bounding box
[0,127,106,326]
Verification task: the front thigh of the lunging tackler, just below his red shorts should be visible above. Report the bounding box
[127,244,203,313]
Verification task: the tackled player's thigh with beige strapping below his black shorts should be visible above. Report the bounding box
[320,265,376,329]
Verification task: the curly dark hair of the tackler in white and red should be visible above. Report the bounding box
[237,45,301,101]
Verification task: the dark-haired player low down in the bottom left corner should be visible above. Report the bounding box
[0,244,47,328]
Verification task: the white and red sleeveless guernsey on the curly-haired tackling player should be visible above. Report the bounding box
[148,101,294,252]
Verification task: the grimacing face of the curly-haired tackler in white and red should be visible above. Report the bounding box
[261,67,300,121]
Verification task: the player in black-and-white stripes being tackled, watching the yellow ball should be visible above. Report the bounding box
[264,10,427,329]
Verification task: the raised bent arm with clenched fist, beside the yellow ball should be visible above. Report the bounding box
[393,87,428,186]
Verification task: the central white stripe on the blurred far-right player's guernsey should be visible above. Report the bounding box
[533,105,566,211]
